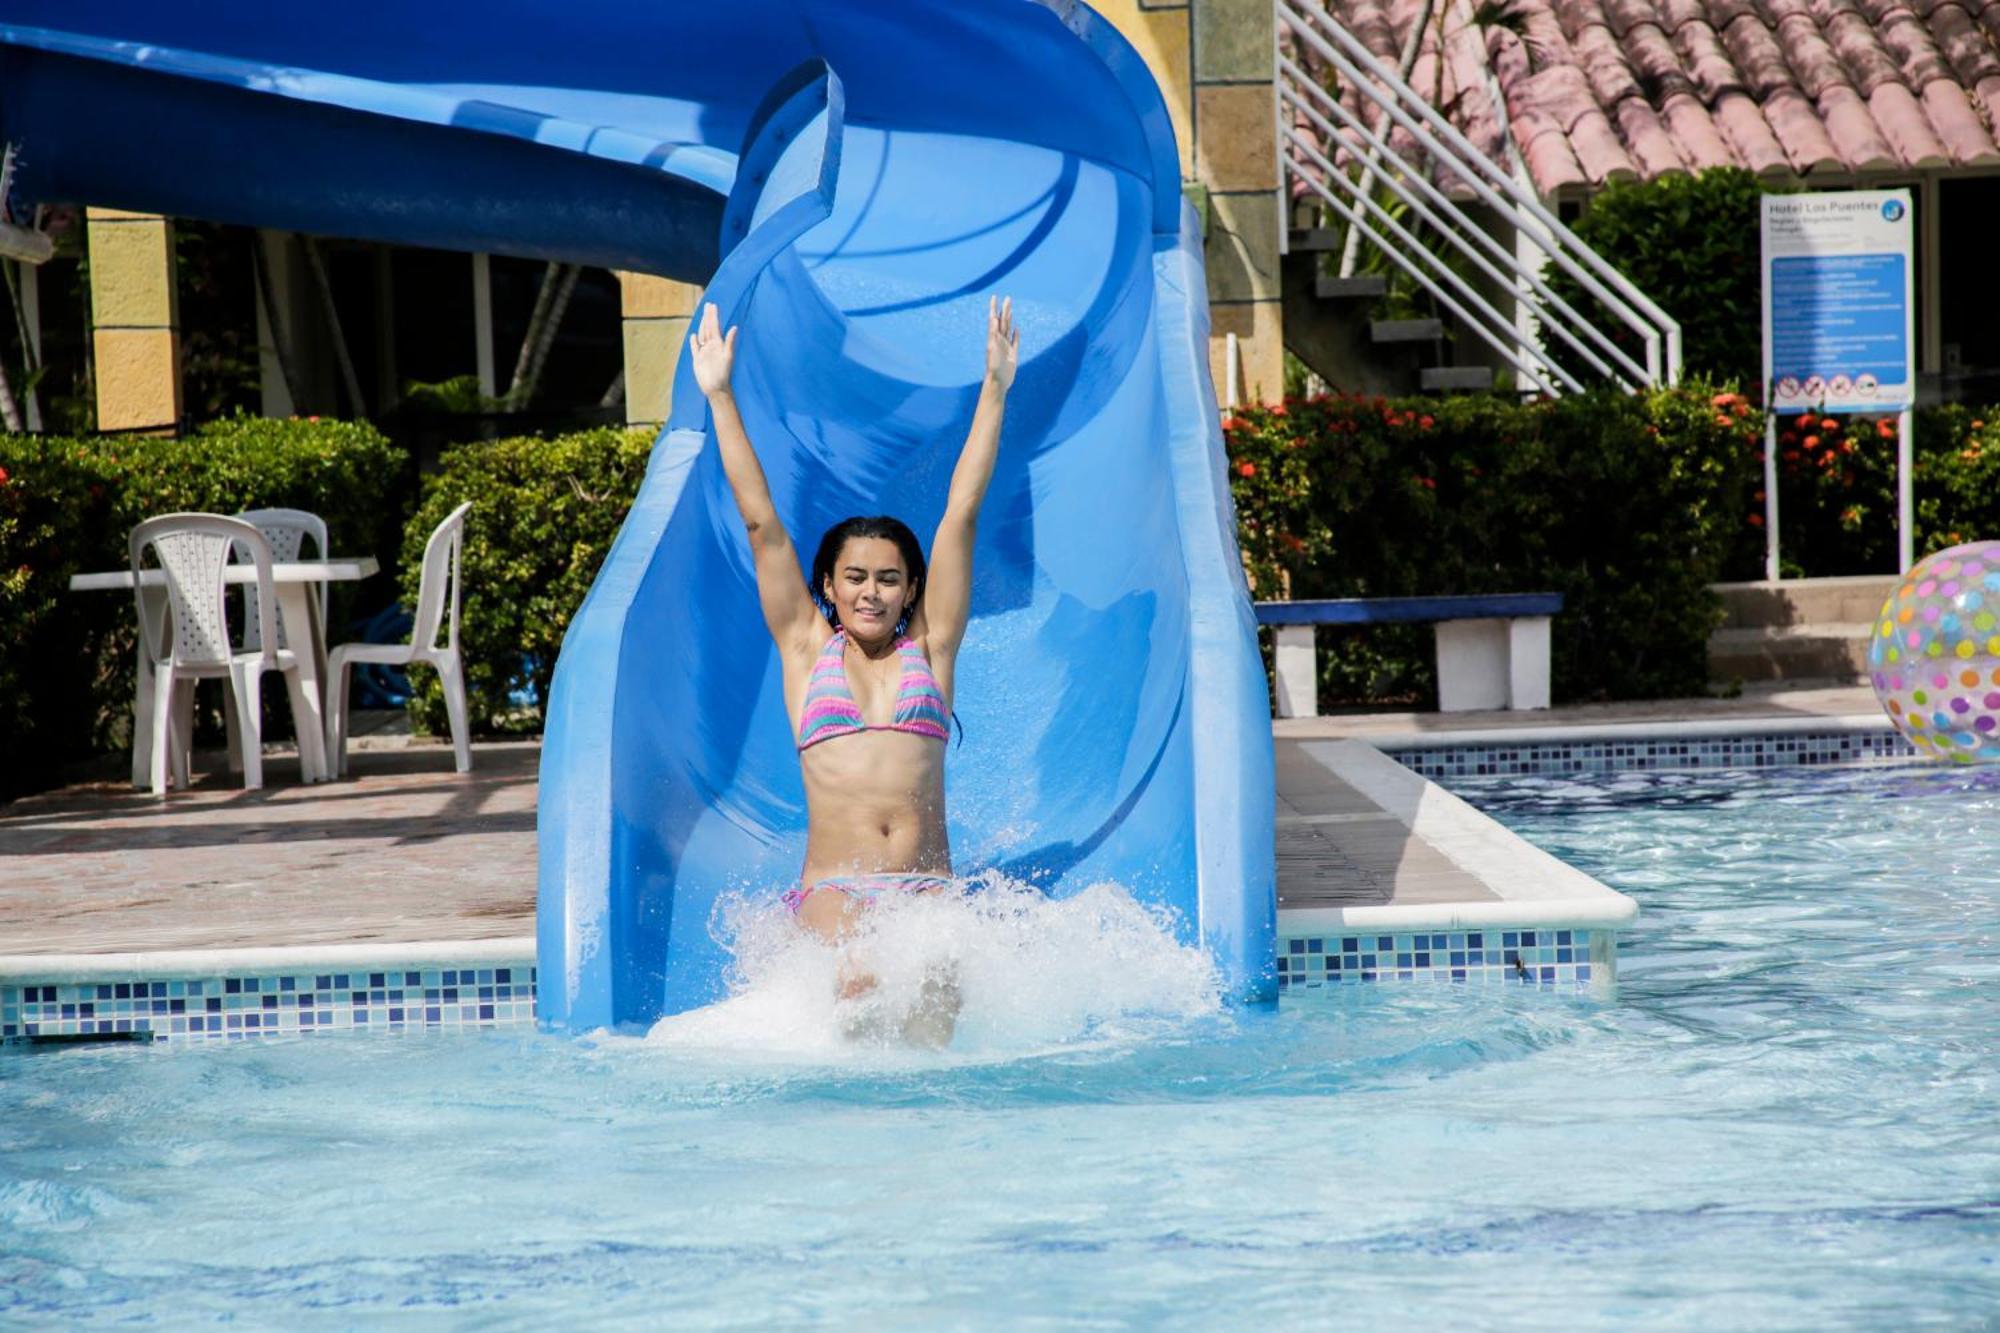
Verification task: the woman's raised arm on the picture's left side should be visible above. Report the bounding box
[690,304,826,652]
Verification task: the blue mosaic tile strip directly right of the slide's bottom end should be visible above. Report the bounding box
[1278,927,1618,995]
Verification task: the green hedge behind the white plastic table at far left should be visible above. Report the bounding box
[0,416,408,799]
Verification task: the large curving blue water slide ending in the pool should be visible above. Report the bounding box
[0,0,1274,1031]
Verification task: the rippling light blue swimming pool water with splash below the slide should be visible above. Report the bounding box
[0,767,2000,1329]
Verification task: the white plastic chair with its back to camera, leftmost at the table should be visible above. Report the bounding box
[132,514,310,797]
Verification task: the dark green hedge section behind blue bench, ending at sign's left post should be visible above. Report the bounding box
[1224,386,1760,703]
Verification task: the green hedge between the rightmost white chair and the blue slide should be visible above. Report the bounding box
[402,428,654,733]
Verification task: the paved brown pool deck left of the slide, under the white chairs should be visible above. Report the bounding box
[0,741,542,957]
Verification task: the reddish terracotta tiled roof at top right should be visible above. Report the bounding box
[1330,0,2000,192]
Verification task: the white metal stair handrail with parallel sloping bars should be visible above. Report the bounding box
[1276,0,1680,384]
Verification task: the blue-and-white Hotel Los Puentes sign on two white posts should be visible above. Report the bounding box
[1764,190,1916,582]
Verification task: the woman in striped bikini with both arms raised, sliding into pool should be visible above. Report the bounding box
[692,300,1020,997]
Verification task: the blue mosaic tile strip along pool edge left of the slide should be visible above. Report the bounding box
[0,967,536,1045]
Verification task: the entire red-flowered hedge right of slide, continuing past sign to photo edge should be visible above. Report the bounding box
[1224,380,2000,707]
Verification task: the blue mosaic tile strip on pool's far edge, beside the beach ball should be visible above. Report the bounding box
[1384,729,1918,783]
